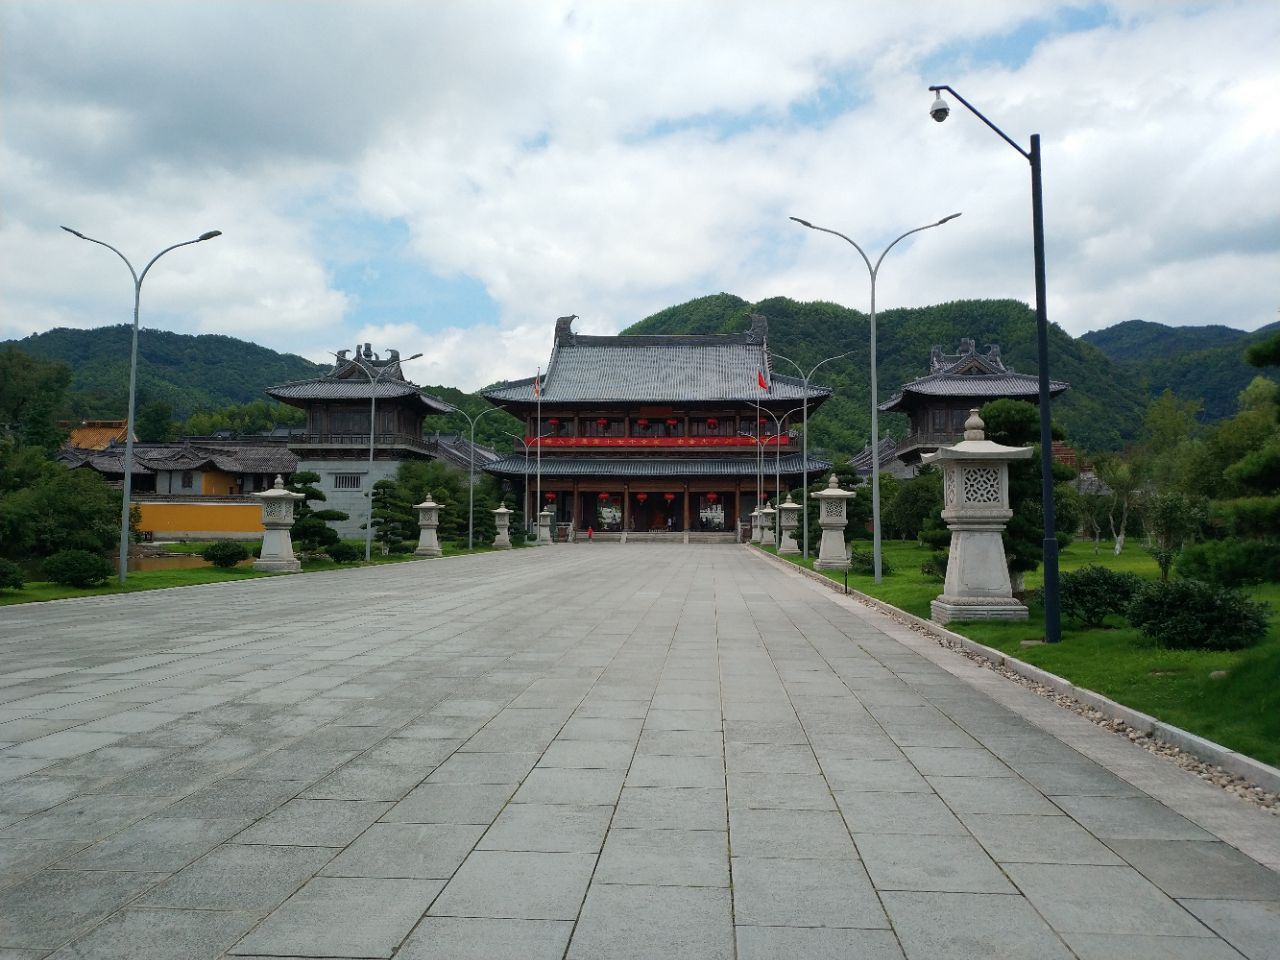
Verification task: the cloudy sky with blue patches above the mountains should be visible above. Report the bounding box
[0,0,1280,389]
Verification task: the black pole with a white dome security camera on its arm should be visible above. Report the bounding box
[929,83,1062,644]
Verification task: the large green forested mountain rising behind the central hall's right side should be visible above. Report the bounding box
[623,293,1146,454]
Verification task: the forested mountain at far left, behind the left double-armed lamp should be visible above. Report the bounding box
[9,324,328,420]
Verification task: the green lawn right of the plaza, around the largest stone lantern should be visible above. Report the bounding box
[762,541,1280,765]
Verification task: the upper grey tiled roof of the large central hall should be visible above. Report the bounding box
[484,317,831,406]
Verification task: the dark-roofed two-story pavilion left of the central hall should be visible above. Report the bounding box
[266,343,453,536]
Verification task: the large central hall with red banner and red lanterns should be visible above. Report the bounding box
[484,316,831,534]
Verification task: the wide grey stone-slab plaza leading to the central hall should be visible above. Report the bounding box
[0,544,1280,960]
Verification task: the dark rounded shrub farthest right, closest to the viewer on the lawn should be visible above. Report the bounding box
[1128,580,1267,650]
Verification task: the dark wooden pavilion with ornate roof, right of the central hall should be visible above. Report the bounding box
[880,338,1070,476]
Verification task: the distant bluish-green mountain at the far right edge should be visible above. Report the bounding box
[1080,320,1280,422]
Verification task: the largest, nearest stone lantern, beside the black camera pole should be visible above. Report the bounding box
[923,410,1032,623]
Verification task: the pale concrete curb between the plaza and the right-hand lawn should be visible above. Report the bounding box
[753,545,1280,792]
